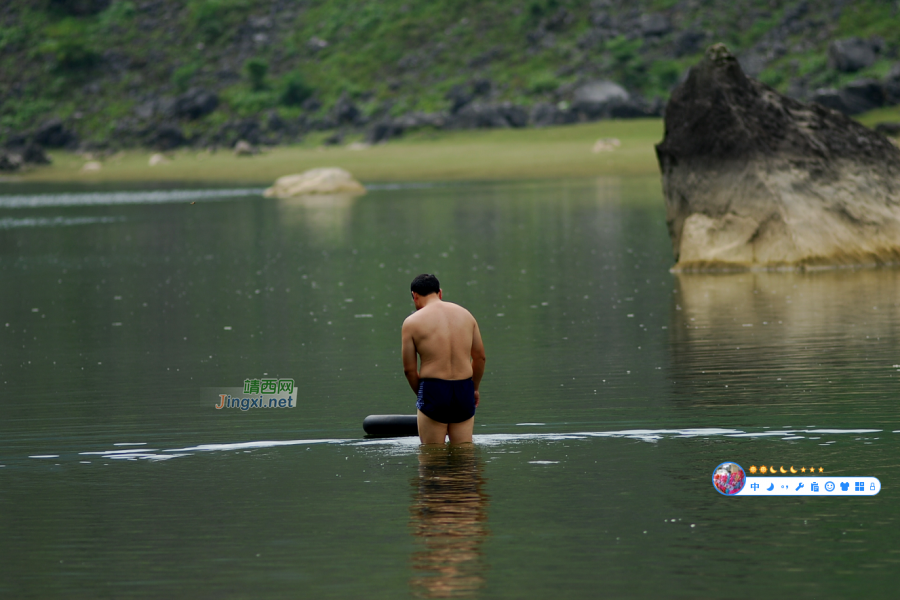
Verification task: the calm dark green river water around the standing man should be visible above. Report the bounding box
[0,178,900,599]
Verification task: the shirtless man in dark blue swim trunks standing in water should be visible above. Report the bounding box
[401,275,485,444]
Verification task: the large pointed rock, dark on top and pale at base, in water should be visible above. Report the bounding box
[656,44,900,270]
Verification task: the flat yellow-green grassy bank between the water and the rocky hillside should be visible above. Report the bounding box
[16,119,662,186]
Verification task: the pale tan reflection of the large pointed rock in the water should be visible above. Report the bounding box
[669,269,900,404]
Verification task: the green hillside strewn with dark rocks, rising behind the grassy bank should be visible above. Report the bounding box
[0,0,900,159]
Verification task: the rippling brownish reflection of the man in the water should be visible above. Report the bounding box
[410,444,488,598]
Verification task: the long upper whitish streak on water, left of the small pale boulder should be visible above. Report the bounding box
[0,188,263,208]
